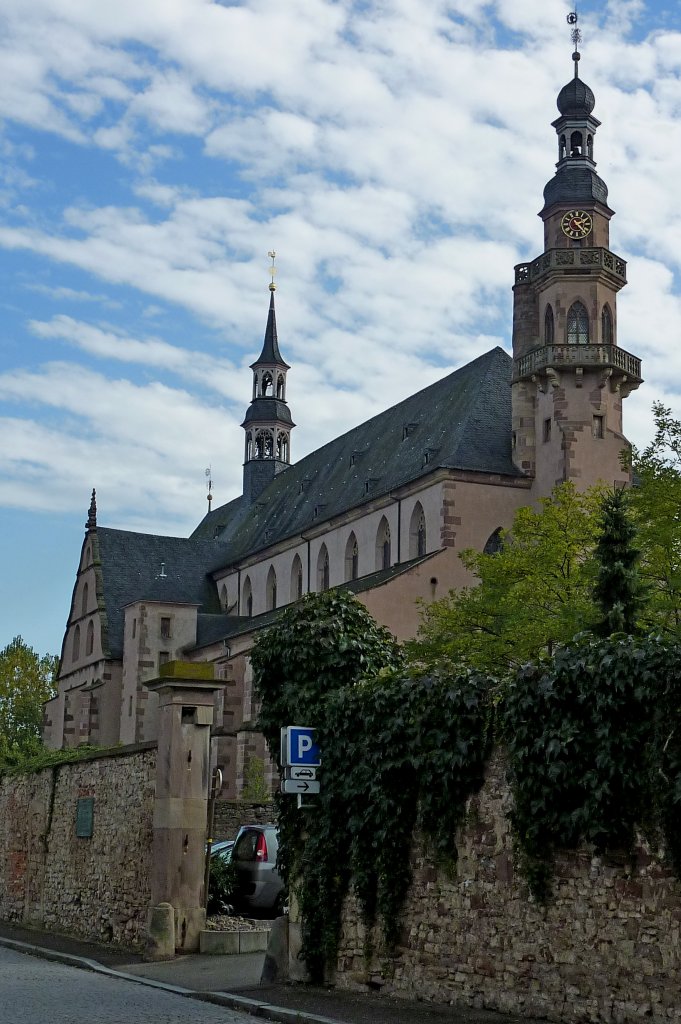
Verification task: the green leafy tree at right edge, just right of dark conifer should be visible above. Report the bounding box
[631,402,681,635]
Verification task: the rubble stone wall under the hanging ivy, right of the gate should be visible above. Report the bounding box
[336,758,681,1024]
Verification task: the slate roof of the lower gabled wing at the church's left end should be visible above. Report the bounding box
[96,526,226,658]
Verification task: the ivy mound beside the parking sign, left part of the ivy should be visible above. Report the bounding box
[252,591,494,980]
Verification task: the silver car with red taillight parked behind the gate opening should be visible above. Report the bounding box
[231,825,287,914]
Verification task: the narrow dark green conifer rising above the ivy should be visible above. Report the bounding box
[594,487,645,637]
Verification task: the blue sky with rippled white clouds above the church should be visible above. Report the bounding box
[0,0,681,653]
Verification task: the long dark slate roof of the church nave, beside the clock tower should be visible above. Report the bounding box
[191,347,521,569]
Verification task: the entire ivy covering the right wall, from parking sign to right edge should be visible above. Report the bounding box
[252,591,681,980]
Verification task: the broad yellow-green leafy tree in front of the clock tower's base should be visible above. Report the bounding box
[408,482,601,674]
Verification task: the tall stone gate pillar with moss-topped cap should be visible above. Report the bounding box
[145,662,223,958]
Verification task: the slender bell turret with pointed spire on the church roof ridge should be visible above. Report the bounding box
[242,252,295,505]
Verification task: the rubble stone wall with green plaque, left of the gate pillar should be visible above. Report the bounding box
[0,743,156,946]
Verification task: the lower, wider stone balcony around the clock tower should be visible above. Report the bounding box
[513,344,643,391]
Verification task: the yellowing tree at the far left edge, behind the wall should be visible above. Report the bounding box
[0,636,58,761]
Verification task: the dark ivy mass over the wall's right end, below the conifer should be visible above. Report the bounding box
[500,635,681,900]
